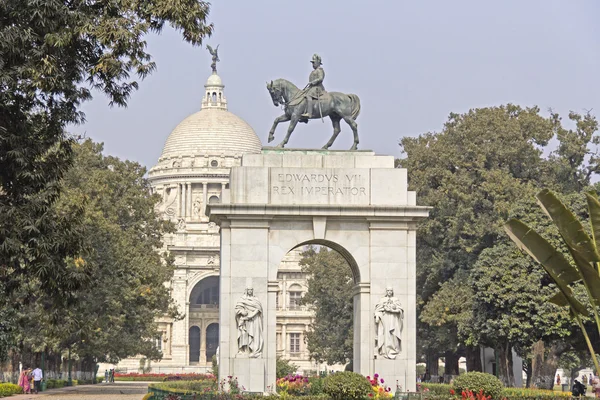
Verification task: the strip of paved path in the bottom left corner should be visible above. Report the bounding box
[10,382,148,400]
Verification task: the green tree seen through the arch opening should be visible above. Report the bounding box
[300,247,354,364]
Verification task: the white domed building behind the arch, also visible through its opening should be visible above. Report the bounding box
[115,64,326,373]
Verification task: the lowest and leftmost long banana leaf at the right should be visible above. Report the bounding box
[504,219,589,316]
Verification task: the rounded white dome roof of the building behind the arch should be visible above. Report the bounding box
[161,108,262,158]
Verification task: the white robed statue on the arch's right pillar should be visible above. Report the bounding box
[375,287,404,360]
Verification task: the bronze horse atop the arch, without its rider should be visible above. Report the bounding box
[267,79,360,150]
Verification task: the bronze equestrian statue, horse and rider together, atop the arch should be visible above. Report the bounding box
[267,54,360,150]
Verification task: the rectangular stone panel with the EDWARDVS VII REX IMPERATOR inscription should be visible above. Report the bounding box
[269,168,371,205]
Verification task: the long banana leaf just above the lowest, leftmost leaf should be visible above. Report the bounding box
[536,189,600,263]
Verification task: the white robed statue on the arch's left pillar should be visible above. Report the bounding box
[235,287,264,358]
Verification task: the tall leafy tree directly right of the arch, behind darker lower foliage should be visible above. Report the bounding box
[399,105,598,382]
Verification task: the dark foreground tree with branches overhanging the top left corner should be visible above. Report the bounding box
[0,0,213,338]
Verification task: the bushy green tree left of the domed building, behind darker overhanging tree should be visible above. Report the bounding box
[15,140,177,366]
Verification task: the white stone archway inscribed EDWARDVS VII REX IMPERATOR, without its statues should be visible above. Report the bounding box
[208,149,428,391]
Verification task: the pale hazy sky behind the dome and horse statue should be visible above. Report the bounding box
[71,0,600,167]
